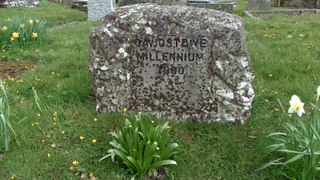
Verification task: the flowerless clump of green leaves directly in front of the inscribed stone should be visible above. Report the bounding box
[101,114,178,178]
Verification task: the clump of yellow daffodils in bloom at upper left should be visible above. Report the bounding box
[0,16,47,49]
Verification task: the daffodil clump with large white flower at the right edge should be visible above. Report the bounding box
[258,87,320,180]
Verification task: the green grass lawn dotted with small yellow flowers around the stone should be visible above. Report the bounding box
[0,0,320,179]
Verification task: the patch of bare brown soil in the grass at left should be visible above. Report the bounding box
[0,60,35,78]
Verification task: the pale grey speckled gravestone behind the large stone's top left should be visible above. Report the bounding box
[87,0,115,21]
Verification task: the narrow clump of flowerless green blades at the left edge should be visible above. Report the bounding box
[0,79,16,151]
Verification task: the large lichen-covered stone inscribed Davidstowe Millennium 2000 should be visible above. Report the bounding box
[89,4,254,123]
